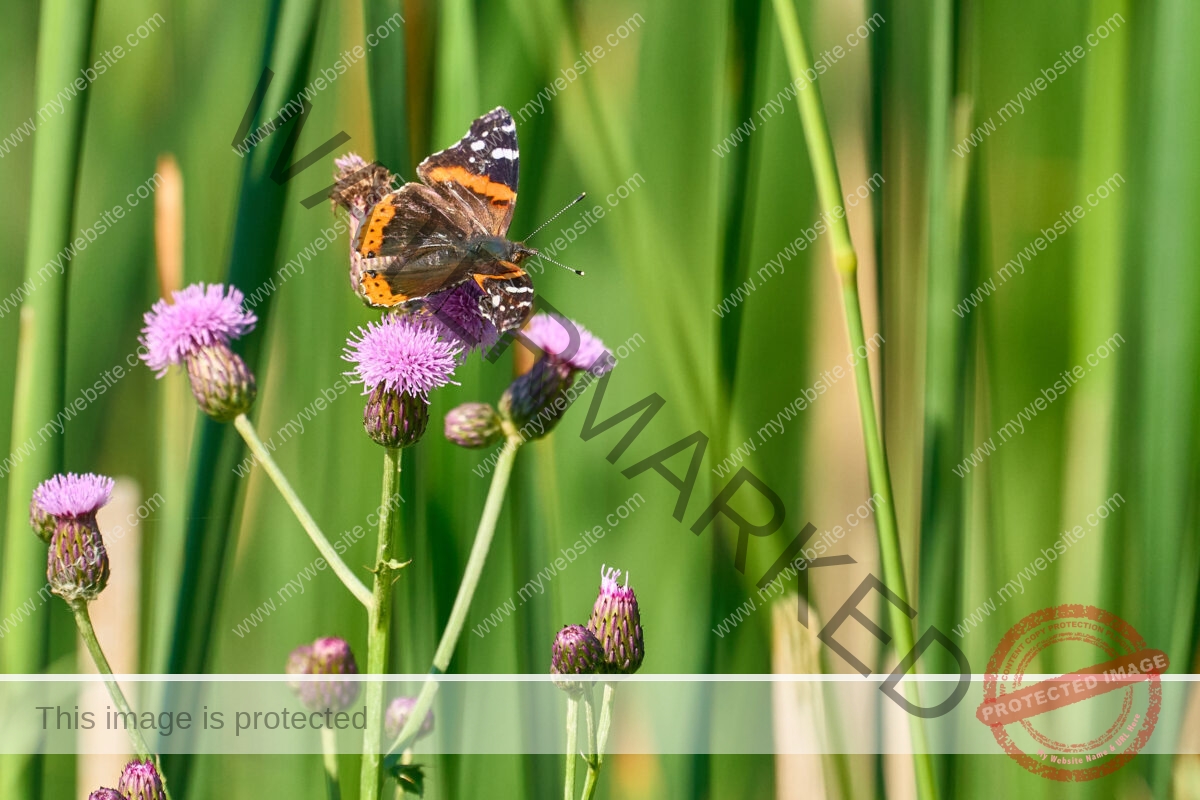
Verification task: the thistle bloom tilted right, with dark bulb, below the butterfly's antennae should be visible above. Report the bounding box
[500,314,613,439]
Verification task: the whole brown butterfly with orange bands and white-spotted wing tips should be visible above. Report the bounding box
[354,107,538,333]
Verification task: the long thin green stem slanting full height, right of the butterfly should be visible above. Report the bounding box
[774,0,937,800]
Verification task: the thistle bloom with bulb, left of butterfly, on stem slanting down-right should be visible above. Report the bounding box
[138,283,258,422]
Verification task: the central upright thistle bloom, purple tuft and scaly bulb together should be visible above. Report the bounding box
[343,315,461,447]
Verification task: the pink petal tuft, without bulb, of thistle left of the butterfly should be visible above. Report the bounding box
[138,283,258,378]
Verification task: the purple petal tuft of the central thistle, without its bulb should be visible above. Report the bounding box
[342,315,460,403]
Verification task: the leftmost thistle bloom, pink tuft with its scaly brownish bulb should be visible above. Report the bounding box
[29,473,113,602]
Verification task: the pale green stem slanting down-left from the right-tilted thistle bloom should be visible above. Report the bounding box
[388,431,521,752]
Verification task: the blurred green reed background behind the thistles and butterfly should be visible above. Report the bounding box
[0,0,1200,799]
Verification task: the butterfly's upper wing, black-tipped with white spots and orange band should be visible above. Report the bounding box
[416,108,518,236]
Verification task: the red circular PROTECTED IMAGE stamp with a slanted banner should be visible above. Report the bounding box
[976,606,1170,781]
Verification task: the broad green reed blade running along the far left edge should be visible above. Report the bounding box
[0,0,96,800]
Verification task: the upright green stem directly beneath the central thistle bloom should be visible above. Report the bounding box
[359,447,400,800]
